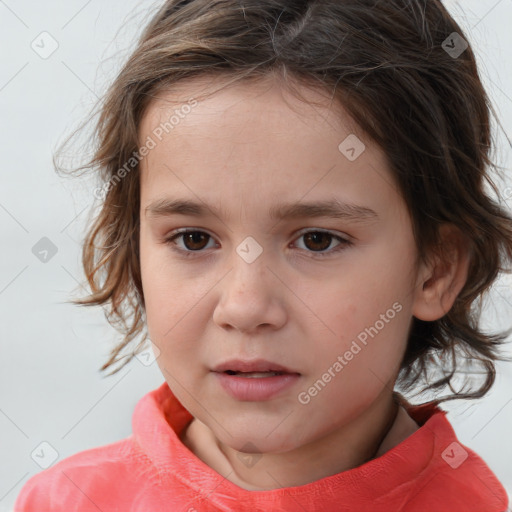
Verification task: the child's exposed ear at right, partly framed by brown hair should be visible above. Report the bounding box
[412,224,470,322]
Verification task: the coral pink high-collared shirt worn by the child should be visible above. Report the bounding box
[14,383,508,512]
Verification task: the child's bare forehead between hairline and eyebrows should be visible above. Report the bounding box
[139,74,402,224]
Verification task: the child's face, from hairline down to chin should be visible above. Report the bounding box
[140,76,424,452]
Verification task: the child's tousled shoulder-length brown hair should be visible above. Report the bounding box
[57,0,512,401]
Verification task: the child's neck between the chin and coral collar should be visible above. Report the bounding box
[181,388,412,490]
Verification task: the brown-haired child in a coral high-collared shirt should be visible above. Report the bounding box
[15,0,512,512]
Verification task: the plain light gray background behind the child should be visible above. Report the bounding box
[0,0,512,512]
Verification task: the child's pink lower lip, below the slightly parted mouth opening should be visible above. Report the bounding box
[215,372,300,401]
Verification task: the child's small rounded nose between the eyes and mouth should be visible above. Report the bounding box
[213,244,287,334]
